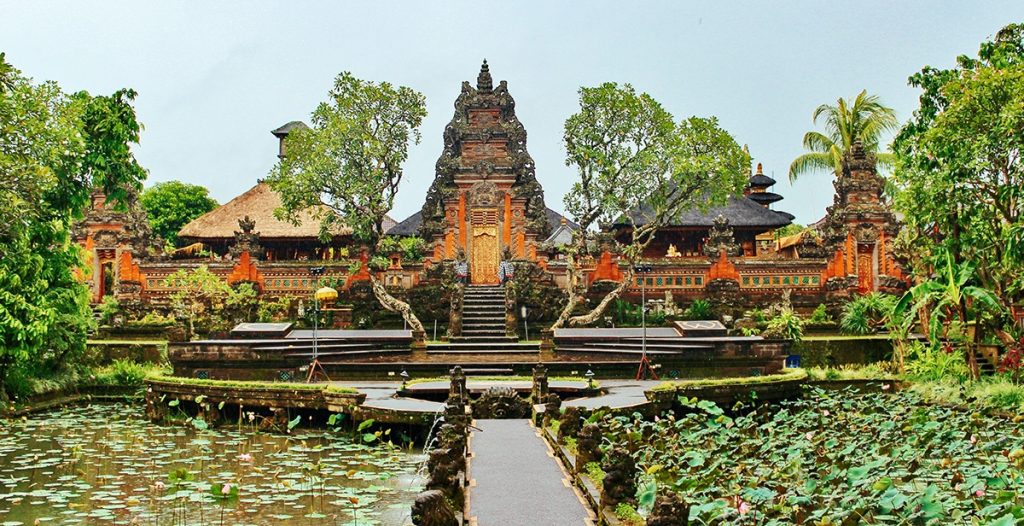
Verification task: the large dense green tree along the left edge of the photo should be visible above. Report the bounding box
[0,54,145,398]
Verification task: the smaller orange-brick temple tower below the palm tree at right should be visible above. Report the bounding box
[821,142,906,304]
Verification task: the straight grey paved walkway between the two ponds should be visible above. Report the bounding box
[468,420,595,526]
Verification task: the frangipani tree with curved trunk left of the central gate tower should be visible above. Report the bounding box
[267,72,427,331]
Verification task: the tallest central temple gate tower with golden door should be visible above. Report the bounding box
[419,60,551,284]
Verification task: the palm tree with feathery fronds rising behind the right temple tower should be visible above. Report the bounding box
[790,90,899,181]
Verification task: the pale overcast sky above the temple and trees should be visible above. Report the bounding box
[0,0,1024,223]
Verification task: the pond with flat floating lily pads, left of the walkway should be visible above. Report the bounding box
[0,404,423,526]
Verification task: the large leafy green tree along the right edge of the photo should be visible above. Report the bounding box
[893,25,1024,340]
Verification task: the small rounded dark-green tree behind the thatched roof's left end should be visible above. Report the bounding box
[140,181,217,244]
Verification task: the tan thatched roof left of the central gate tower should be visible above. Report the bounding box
[178,181,354,239]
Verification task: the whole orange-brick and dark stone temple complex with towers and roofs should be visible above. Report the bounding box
[75,61,906,323]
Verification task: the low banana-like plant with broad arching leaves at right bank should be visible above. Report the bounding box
[894,252,1000,379]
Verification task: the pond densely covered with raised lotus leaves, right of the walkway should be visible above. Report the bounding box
[587,382,1024,526]
